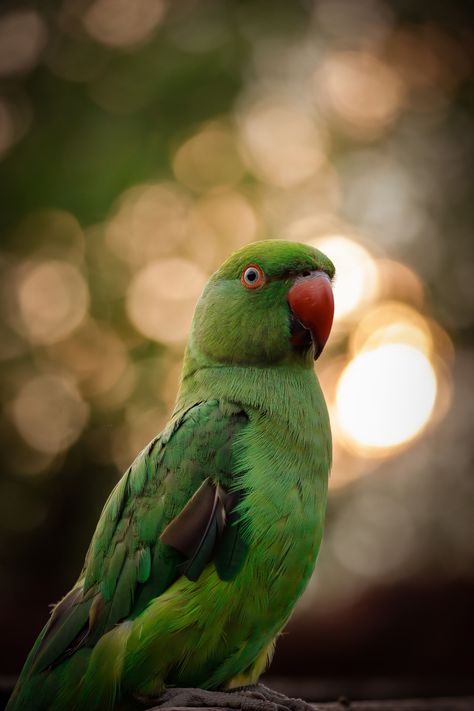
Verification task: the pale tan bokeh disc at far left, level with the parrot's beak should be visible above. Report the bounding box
[14,260,89,344]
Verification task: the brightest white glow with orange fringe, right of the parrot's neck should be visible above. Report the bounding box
[324,301,452,472]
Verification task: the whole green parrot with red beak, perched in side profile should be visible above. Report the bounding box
[7,240,334,711]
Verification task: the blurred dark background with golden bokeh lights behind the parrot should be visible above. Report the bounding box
[0,0,474,698]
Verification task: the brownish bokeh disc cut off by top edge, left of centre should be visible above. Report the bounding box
[83,0,165,47]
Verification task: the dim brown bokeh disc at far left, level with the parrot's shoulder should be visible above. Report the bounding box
[11,375,89,454]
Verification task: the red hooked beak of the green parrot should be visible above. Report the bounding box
[288,270,334,360]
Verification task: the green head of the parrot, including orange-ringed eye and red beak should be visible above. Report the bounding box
[189,240,335,366]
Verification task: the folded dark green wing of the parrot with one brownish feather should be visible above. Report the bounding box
[24,400,248,673]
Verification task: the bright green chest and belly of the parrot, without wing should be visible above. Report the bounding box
[133,369,331,688]
